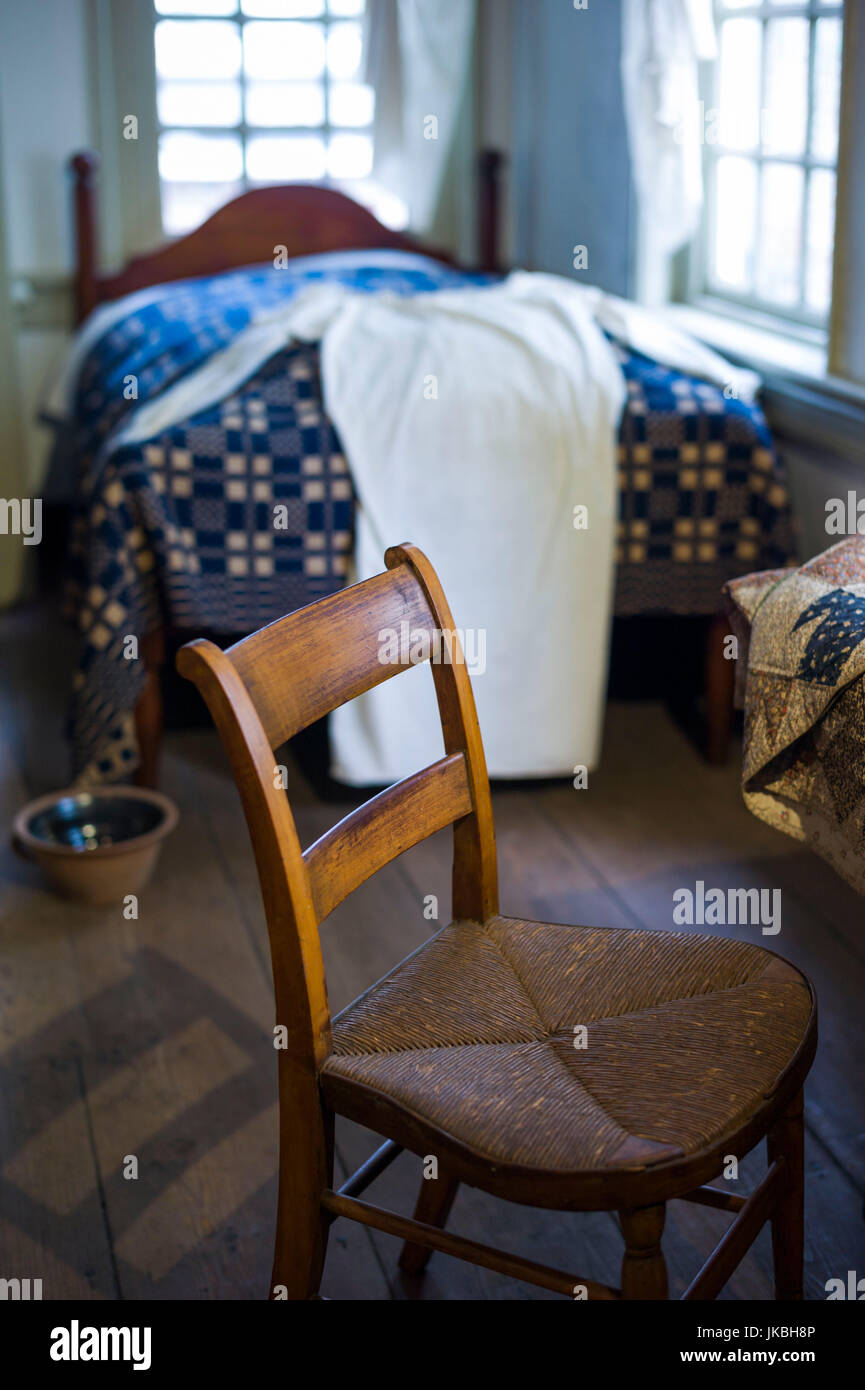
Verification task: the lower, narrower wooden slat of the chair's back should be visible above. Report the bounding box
[303,753,471,922]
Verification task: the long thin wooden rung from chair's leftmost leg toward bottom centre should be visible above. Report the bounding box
[321,1191,620,1300]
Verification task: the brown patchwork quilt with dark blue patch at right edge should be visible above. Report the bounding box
[726,535,865,892]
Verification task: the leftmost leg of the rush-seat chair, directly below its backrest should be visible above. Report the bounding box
[270,1073,334,1301]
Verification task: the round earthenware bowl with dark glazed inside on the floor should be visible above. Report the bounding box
[13,787,178,905]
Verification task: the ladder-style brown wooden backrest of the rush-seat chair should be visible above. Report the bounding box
[177,545,498,1066]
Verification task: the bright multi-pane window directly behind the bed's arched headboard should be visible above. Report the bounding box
[154,0,405,235]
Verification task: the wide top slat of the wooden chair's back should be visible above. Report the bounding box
[225,566,435,748]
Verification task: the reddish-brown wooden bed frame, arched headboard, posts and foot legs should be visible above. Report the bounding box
[70,150,734,787]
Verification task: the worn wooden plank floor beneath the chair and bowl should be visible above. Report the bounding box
[0,610,865,1300]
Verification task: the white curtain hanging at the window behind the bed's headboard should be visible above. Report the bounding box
[364,0,476,232]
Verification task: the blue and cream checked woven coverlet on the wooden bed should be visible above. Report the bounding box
[54,253,794,781]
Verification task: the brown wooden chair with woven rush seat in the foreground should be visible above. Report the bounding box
[178,545,816,1300]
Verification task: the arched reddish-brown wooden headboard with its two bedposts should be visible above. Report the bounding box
[70,150,503,322]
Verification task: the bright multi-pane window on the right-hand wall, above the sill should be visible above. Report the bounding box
[693,0,841,328]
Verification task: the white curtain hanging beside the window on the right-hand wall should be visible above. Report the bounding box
[622,0,716,254]
